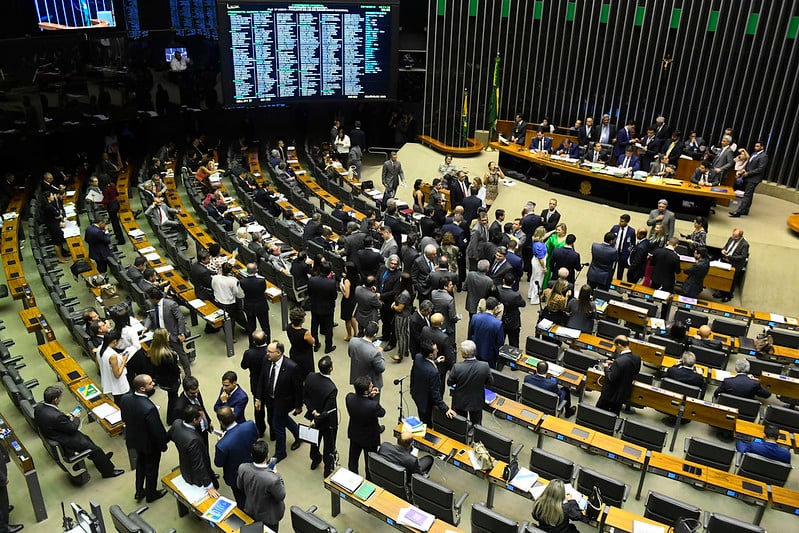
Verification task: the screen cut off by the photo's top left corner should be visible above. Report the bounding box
[34,0,116,31]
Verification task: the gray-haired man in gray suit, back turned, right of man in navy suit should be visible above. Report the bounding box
[447,340,494,424]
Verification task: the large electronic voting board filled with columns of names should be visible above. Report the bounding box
[217,0,399,107]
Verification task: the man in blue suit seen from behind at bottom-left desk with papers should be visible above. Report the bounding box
[214,407,258,509]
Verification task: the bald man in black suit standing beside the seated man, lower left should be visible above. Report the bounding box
[119,374,169,503]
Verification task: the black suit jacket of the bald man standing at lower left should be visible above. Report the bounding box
[118,392,169,454]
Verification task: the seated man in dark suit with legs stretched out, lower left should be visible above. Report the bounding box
[33,385,125,478]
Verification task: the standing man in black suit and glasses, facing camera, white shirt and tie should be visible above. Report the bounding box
[254,342,302,462]
